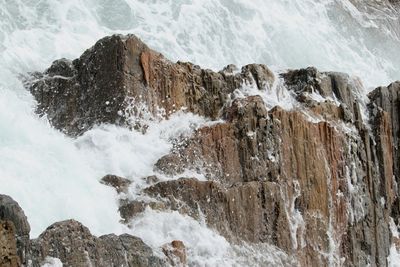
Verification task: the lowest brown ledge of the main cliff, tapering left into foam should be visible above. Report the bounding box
[146,178,291,247]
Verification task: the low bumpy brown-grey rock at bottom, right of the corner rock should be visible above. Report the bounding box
[31,220,165,267]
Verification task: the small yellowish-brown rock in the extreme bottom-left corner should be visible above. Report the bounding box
[0,220,21,267]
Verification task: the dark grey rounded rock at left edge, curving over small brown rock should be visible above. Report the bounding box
[0,195,31,265]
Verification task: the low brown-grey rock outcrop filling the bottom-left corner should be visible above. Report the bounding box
[0,195,166,267]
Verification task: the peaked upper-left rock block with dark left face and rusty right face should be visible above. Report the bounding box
[27,35,274,136]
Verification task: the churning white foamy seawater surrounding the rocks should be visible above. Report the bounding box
[0,0,400,266]
